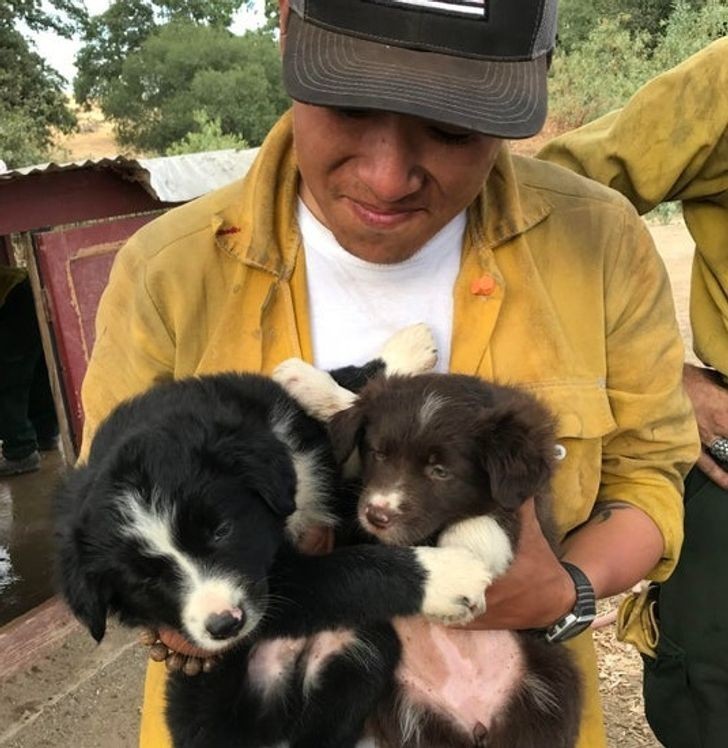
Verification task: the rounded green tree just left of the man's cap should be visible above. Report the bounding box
[104,21,289,153]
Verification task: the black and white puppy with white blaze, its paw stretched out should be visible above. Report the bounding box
[55,328,487,748]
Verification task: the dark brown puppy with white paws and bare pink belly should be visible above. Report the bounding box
[275,360,581,748]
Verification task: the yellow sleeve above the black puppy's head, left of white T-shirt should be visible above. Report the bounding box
[80,238,174,460]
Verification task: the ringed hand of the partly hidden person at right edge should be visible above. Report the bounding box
[683,364,728,490]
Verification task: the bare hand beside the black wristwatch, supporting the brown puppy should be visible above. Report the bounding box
[465,499,576,629]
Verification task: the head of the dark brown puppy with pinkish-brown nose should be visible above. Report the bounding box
[329,374,555,545]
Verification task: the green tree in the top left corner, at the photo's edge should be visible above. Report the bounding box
[0,0,86,166]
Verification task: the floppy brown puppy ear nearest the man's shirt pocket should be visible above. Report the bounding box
[478,398,555,510]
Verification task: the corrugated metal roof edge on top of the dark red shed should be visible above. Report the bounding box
[0,148,258,203]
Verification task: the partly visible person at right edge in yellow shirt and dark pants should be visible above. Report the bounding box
[539,38,728,748]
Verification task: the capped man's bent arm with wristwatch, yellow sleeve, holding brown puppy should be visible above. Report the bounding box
[466,203,698,628]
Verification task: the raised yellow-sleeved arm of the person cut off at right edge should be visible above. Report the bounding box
[537,38,728,214]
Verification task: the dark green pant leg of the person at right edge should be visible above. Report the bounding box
[644,468,728,748]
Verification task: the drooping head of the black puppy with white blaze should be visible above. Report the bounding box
[57,416,296,651]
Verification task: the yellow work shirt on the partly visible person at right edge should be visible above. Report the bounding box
[538,37,728,376]
